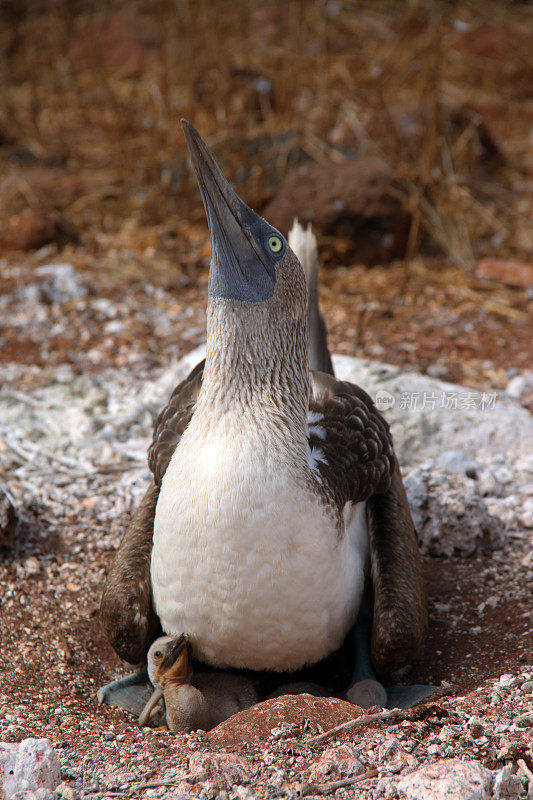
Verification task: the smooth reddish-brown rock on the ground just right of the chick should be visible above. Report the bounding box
[209,694,363,747]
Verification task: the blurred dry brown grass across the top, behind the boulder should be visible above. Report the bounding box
[0,0,533,267]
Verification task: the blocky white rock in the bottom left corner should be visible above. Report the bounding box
[0,739,61,800]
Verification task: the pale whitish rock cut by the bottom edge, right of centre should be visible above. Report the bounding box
[396,758,492,800]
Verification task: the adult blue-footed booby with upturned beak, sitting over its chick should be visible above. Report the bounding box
[100,121,426,706]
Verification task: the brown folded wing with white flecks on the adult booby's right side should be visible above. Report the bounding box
[309,372,427,672]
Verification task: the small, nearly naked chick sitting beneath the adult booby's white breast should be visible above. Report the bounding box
[138,635,259,733]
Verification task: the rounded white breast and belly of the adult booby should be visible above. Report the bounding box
[152,416,368,670]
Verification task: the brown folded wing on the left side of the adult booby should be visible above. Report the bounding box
[100,361,204,664]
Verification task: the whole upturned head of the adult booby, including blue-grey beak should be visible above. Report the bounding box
[182,120,307,334]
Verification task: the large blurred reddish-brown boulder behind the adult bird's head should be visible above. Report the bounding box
[264,158,411,264]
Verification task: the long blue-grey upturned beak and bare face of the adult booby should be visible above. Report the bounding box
[181,120,287,303]
